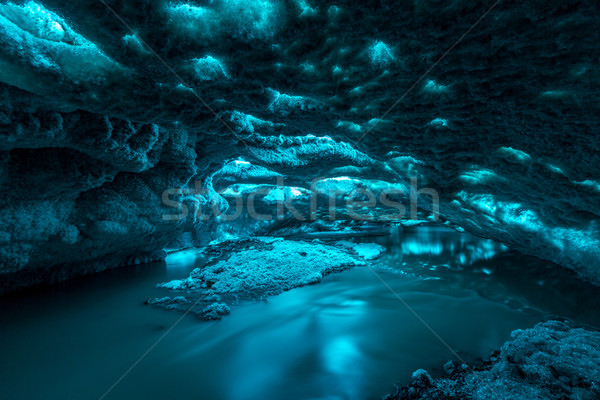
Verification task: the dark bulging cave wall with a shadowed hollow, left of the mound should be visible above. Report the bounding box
[0,101,196,284]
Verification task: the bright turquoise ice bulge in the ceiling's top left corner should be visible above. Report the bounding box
[0,1,122,95]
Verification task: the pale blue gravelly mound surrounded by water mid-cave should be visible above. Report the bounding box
[147,237,366,320]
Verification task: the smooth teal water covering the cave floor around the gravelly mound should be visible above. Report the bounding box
[0,227,600,400]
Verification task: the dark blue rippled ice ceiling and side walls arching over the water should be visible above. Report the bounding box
[0,0,600,288]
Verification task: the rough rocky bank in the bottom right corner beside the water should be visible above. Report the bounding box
[386,321,600,400]
